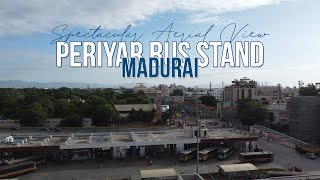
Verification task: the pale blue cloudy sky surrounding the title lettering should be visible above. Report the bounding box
[0,0,320,87]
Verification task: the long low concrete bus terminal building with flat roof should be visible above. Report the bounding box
[0,126,257,159]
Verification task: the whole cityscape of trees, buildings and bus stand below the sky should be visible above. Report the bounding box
[0,77,320,179]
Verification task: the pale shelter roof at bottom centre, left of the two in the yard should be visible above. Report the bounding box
[140,168,177,178]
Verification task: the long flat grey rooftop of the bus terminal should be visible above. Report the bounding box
[0,129,252,149]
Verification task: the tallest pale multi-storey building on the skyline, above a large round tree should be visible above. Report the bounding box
[224,77,257,107]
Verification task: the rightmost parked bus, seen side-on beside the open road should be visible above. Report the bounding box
[239,151,273,163]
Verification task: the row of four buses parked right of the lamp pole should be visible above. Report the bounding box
[178,147,273,162]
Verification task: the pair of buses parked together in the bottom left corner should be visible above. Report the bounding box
[0,156,45,179]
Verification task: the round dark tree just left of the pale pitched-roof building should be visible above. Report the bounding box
[92,104,119,126]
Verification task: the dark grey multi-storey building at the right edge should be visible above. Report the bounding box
[288,96,320,143]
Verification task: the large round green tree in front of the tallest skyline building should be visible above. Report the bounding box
[237,99,267,126]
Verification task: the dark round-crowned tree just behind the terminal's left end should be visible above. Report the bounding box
[20,102,47,127]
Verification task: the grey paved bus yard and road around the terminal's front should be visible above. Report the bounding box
[21,139,320,180]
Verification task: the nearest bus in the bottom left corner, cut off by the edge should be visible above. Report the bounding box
[0,161,36,179]
